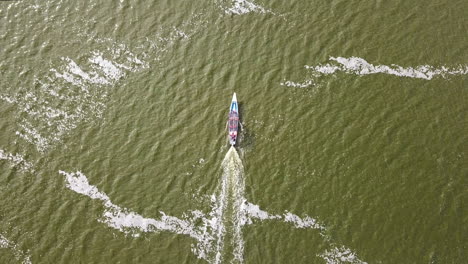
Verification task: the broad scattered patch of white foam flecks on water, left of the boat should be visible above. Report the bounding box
[0,13,207,153]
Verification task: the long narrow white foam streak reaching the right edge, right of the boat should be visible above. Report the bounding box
[305,57,468,80]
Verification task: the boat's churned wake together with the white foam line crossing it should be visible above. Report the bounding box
[59,146,365,263]
